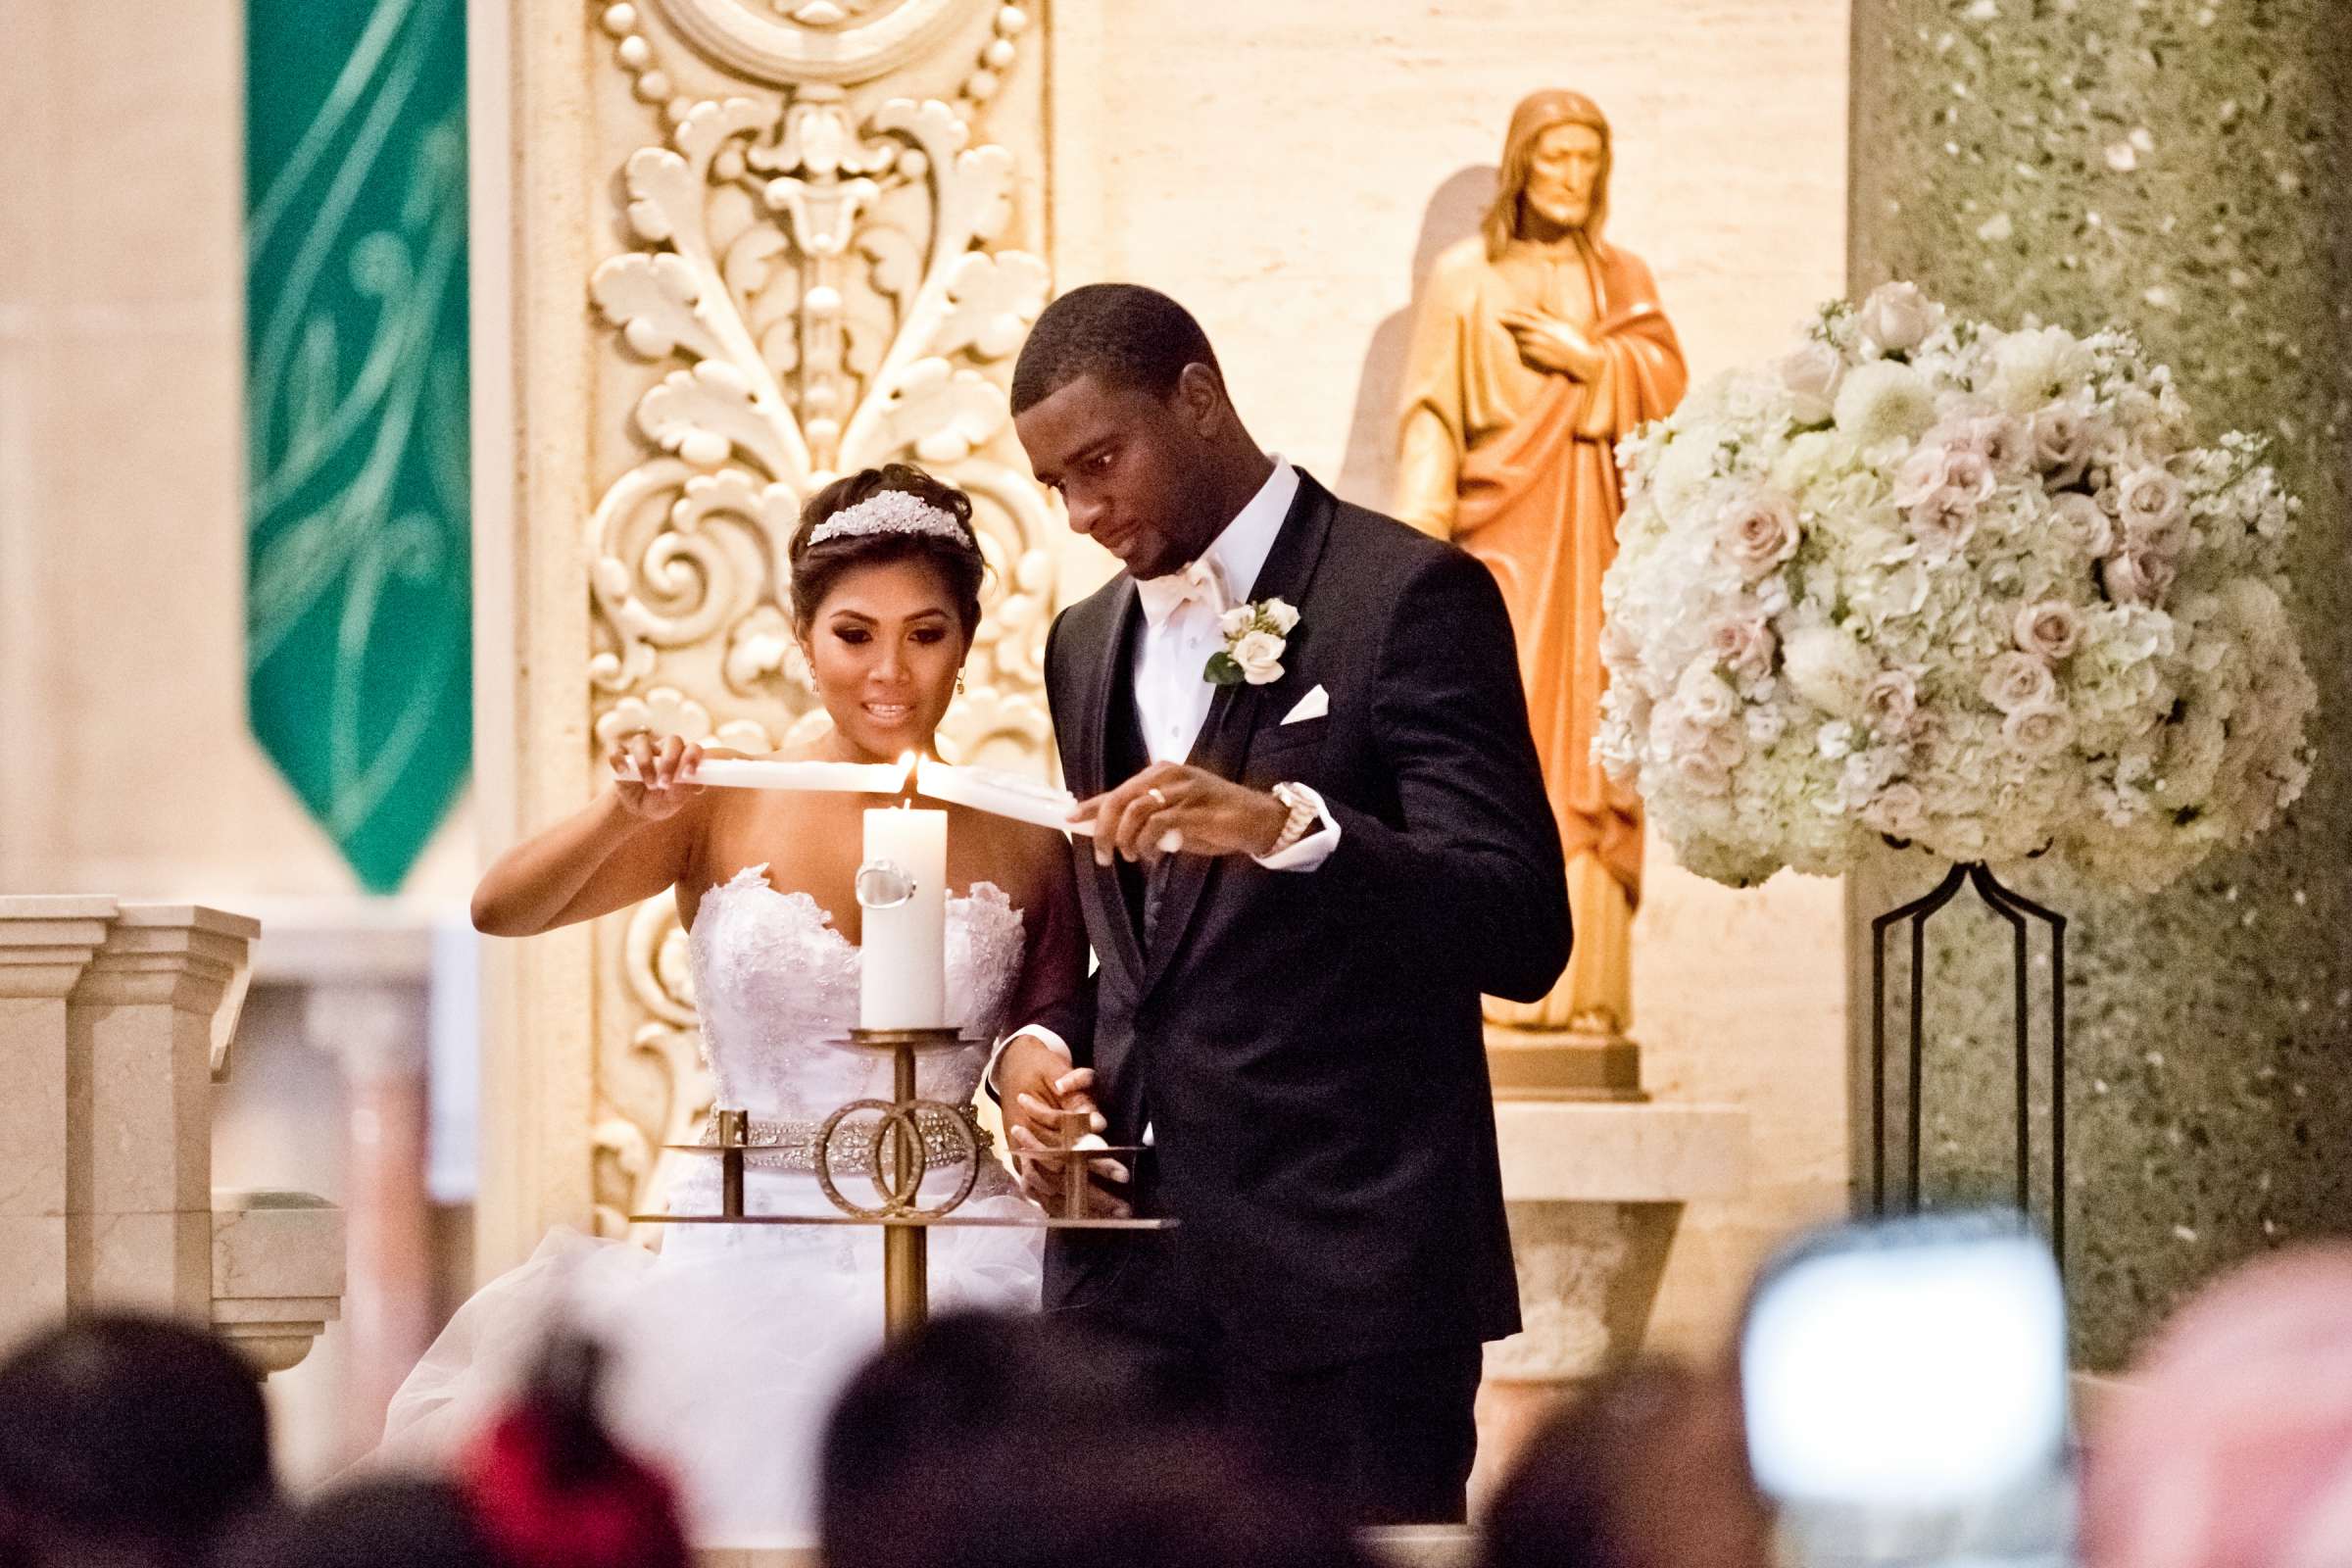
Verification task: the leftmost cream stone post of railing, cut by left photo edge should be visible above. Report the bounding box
[0,898,116,1340]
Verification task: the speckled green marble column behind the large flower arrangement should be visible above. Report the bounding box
[1848,0,2352,1366]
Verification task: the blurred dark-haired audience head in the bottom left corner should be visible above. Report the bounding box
[0,1314,275,1568]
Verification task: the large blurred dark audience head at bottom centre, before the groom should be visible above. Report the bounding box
[821,1314,1364,1568]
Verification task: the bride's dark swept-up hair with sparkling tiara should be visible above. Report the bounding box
[790,464,988,644]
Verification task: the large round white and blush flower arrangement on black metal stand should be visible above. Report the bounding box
[1594,284,2317,891]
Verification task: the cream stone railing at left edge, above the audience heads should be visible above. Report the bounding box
[0,896,343,1375]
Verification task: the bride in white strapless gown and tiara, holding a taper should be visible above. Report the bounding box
[378,464,1087,1543]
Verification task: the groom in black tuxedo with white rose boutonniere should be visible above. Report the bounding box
[993,284,1569,1523]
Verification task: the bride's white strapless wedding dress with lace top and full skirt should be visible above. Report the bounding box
[376,865,1042,1544]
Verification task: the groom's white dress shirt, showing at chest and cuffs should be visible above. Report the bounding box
[986,456,1339,1091]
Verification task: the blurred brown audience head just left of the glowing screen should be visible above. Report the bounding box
[1484,1361,1771,1568]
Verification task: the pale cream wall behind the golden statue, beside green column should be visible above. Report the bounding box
[1052,0,1848,1345]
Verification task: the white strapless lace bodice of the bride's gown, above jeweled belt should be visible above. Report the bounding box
[689,865,1023,1121]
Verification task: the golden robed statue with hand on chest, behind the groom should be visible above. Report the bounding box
[1397,92,1687,1067]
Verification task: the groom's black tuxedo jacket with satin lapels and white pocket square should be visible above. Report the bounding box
[1042,475,1569,1366]
